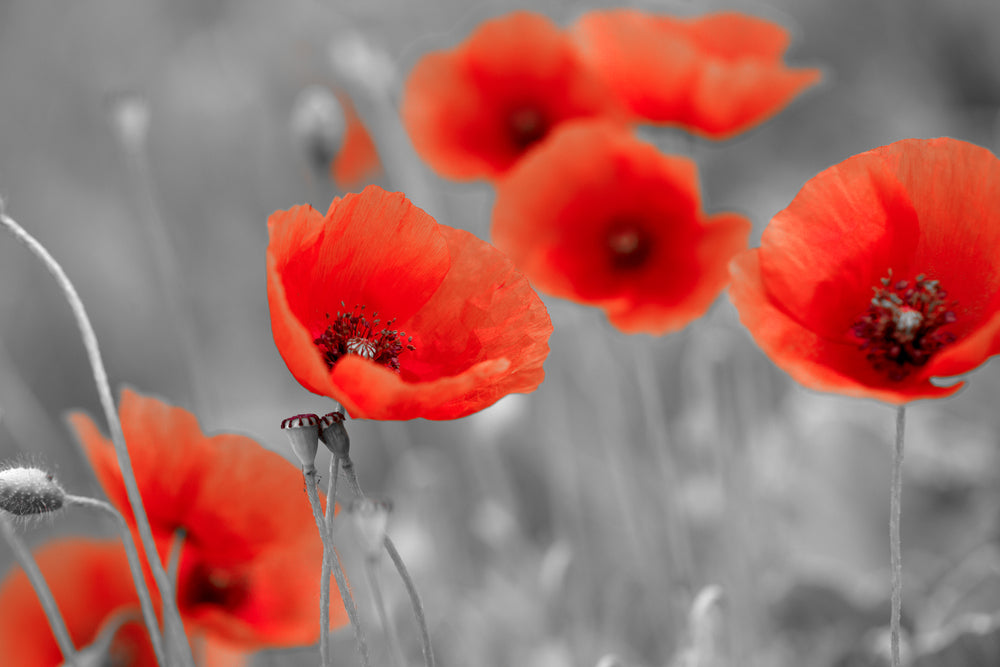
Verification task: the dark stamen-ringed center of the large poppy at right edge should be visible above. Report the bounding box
[851,270,957,382]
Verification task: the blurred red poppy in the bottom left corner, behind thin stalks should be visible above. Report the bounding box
[0,539,157,667]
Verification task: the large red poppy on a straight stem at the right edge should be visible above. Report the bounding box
[731,139,1000,404]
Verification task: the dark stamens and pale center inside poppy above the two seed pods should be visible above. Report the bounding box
[313,302,416,373]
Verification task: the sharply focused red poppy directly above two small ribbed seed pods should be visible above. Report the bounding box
[267,186,552,419]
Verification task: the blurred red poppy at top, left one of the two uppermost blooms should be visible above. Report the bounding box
[402,11,621,179]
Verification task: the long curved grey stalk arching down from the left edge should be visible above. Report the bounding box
[0,209,194,667]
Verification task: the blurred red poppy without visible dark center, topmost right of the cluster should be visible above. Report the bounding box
[572,9,821,139]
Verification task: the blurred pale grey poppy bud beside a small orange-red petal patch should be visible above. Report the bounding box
[291,86,347,173]
